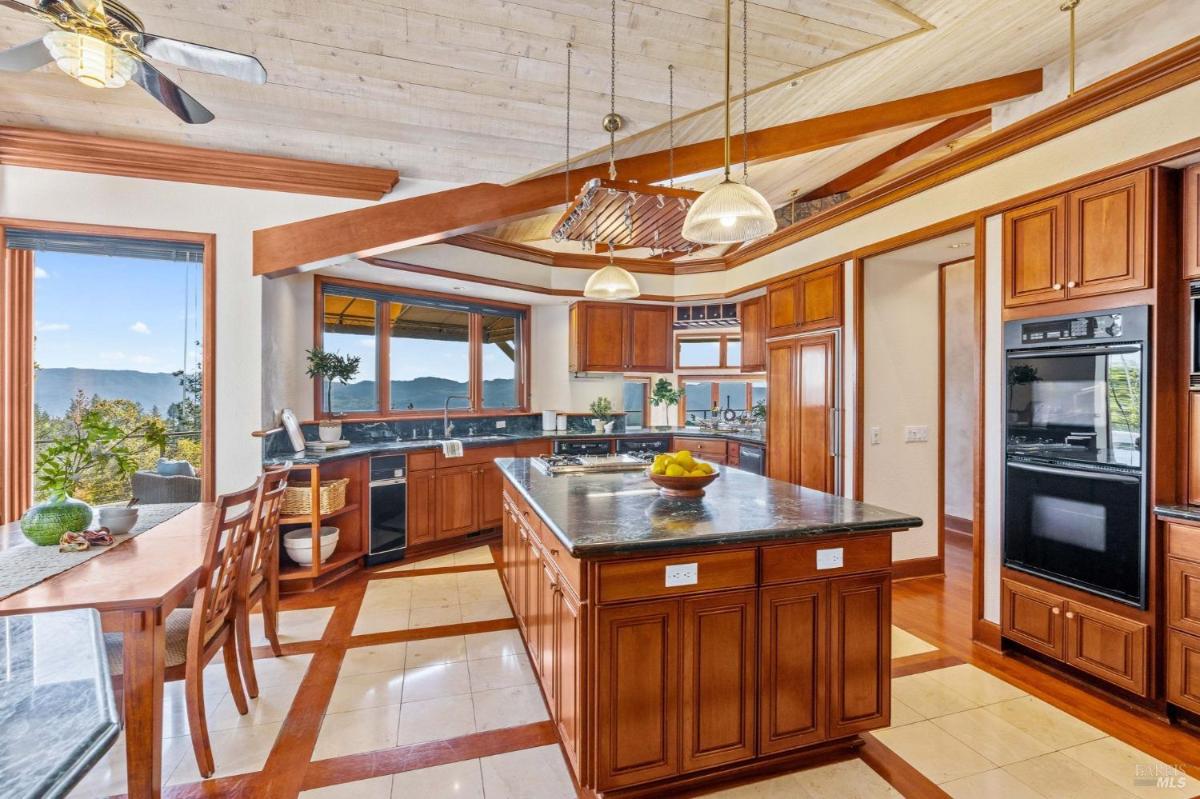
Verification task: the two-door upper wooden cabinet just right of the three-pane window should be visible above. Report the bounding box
[570,302,674,372]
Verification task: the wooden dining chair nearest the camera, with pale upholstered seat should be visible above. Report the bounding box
[104,480,262,777]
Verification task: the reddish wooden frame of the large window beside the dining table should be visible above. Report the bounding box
[0,217,217,503]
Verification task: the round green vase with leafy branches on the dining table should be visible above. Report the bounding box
[20,408,167,546]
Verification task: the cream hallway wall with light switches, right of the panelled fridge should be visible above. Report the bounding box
[863,252,942,560]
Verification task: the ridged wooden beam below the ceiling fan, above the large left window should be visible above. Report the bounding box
[0,127,400,200]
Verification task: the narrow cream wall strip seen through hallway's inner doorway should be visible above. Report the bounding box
[942,260,976,519]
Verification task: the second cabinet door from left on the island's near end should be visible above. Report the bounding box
[682,590,757,771]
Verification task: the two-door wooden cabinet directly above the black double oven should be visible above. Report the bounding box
[1003,170,1152,308]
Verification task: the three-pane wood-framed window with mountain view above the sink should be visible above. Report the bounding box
[318,280,528,416]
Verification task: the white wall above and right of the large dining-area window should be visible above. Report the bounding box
[0,167,444,491]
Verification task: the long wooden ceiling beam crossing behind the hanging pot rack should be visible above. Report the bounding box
[254,70,1042,275]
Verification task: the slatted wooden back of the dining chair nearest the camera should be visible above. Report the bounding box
[192,481,259,642]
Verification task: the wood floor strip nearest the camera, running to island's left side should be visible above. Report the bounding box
[302,721,558,799]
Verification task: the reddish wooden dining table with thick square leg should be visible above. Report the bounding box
[0,503,215,799]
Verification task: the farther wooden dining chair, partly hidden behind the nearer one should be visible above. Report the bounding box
[234,467,289,699]
